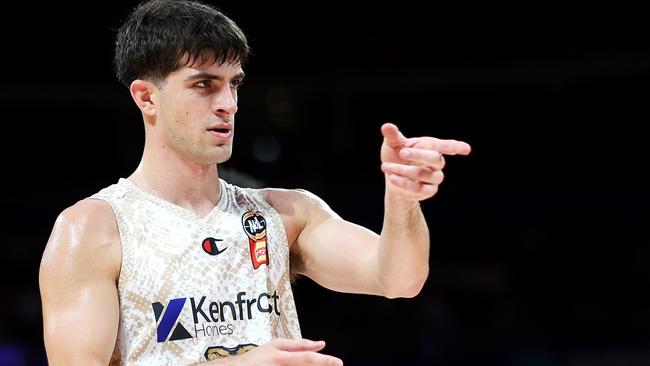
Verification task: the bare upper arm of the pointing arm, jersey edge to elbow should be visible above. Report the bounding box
[266,189,381,294]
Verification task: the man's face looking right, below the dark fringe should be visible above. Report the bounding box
[155,63,244,164]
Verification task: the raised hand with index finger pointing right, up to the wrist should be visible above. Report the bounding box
[381,123,471,201]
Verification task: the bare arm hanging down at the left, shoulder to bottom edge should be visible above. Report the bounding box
[39,199,121,366]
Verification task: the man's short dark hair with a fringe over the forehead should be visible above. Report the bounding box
[114,0,250,87]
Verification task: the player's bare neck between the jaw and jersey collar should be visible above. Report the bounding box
[128,143,221,216]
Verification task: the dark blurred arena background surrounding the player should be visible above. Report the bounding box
[0,1,650,366]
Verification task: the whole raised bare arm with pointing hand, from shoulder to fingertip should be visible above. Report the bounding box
[268,124,470,298]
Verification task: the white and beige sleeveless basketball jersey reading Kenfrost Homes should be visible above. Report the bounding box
[91,178,301,365]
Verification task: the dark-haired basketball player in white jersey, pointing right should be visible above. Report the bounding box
[40,0,470,366]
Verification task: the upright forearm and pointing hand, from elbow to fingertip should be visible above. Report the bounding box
[377,123,471,297]
